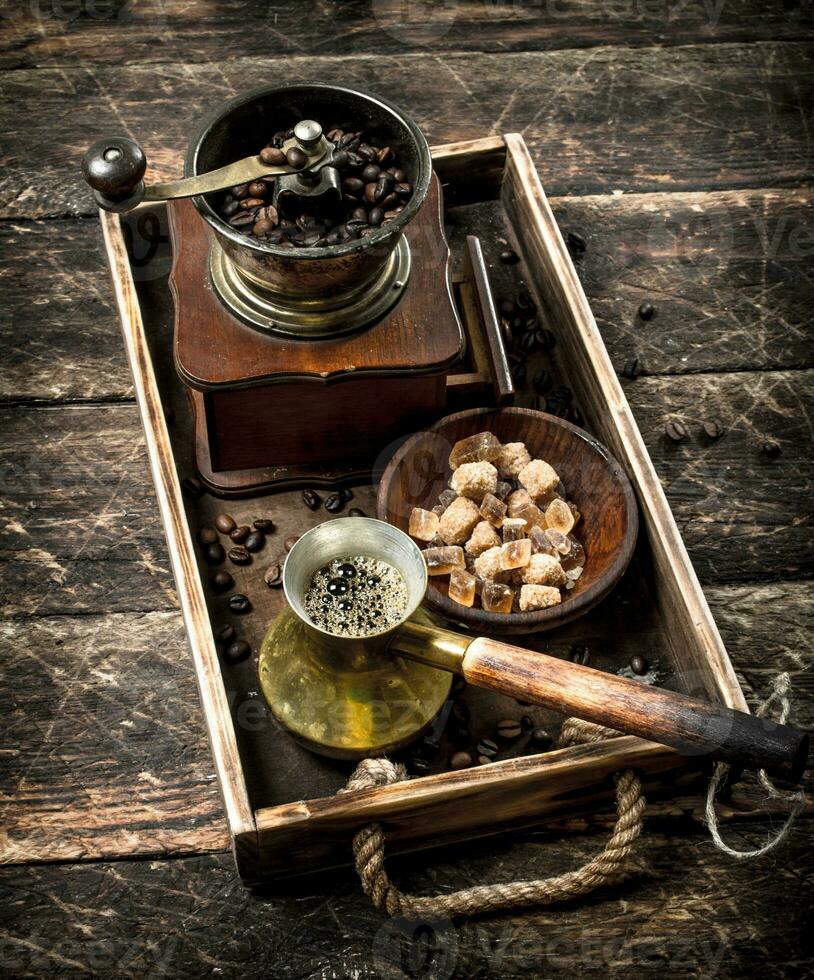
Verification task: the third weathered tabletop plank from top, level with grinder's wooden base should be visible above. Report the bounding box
[0,188,814,401]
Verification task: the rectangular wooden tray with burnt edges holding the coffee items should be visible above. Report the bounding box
[102,134,747,882]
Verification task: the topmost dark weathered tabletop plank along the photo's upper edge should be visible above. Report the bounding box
[0,0,812,68]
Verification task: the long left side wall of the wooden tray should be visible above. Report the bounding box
[100,211,257,874]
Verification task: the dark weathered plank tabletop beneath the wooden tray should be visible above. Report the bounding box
[0,0,814,980]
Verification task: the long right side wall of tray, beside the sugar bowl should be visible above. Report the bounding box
[501,133,749,711]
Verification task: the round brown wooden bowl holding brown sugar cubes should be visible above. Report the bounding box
[377,408,639,633]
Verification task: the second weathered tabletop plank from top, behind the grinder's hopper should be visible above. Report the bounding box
[0,43,812,217]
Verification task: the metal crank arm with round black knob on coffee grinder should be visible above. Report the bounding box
[82,120,334,212]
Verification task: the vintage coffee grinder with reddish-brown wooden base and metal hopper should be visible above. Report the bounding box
[84,84,512,495]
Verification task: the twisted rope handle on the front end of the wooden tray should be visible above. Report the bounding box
[341,718,646,920]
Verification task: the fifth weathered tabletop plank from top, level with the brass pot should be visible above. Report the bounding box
[0,582,814,863]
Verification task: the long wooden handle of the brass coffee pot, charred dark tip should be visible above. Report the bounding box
[391,621,808,783]
